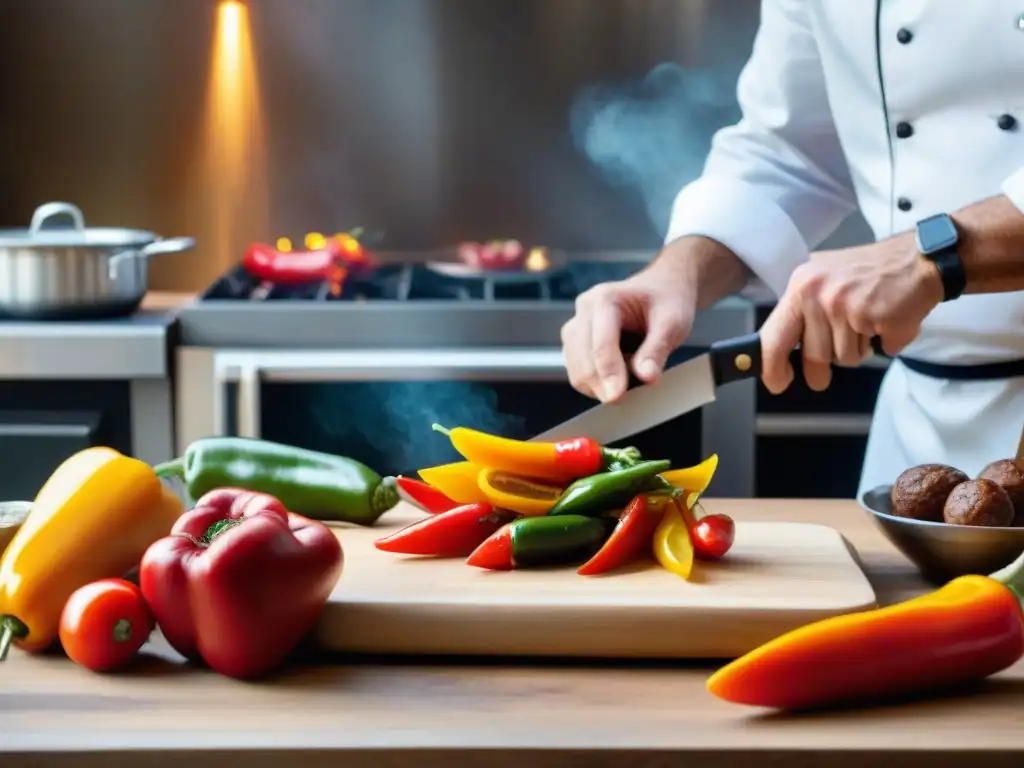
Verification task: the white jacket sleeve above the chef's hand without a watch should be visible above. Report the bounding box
[666,0,856,296]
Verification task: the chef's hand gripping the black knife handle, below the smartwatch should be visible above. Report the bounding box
[761,234,943,394]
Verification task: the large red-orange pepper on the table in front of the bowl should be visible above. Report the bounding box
[707,555,1024,710]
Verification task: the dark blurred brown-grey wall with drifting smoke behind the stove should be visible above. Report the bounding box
[0,0,868,290]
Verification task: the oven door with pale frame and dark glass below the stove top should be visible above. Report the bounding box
[177,348,755,497]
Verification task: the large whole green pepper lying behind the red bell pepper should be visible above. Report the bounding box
[154,437,399,525]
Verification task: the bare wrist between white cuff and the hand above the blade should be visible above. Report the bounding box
[649,236,751,309]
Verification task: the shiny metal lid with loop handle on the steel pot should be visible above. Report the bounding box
[0,203,159,248]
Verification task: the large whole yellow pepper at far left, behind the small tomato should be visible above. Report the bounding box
[0,447,184,660]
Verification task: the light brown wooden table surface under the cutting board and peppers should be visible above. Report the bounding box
[0,499,1024,768]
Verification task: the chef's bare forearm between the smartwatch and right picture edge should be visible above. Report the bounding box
[952,195,1024,293]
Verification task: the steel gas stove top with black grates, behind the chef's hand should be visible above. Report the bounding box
[180,251,651,348]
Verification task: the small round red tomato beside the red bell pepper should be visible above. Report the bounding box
[59,579,154,672]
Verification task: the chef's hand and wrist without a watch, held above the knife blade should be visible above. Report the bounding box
[562,237,748,402]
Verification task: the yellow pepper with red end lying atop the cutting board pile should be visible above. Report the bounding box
[433,424,640,483]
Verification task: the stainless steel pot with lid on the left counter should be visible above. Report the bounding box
[0,203,196,319]
